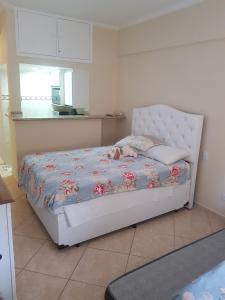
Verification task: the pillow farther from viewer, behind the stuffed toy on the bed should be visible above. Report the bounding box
[115,135,162,151]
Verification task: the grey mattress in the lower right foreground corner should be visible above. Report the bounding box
[105,229,225,300]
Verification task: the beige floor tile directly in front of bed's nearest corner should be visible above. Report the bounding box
[26,241,85,278]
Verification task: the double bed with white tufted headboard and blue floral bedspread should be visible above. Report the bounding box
[20,105,203,247]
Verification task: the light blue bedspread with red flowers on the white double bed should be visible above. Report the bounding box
[19,147,188,213]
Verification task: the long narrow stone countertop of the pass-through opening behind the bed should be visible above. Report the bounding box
[8,113,125,121]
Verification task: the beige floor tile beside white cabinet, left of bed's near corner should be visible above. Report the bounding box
[13,235,45,268]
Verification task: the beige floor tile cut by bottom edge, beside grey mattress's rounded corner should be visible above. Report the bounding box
[60,281,105,300]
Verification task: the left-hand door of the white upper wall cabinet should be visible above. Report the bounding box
[17,9,57,56]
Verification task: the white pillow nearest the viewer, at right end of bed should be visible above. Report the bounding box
[140,145,190,165]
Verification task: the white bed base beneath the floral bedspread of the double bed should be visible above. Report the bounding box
[27,181,190,246]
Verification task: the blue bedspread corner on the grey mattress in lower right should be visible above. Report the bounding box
[174,261,225,300]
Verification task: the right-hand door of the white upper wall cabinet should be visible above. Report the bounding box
[58,19,91,62]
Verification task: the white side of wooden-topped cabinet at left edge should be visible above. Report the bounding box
[0,203,16,300]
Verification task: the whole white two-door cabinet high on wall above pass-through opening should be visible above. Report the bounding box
[16,9,92,63]
